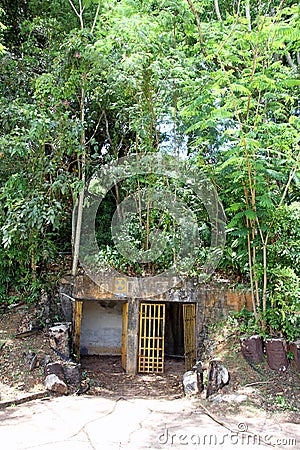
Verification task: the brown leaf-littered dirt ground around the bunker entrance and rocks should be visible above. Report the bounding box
[0,305,300,423]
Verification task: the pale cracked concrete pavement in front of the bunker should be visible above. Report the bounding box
[0,397,300,450]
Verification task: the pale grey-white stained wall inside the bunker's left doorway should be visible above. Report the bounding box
[80,301,122,355]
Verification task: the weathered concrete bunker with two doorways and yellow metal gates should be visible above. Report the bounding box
[60,276,251,374]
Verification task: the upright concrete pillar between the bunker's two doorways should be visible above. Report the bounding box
[126,298,140,375]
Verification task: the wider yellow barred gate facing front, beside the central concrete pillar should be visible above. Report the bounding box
[138,303,165,373]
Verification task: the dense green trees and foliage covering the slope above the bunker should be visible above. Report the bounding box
[0,0,300,331]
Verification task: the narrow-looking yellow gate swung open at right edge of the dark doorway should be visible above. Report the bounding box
[182,303,196,370]
